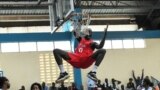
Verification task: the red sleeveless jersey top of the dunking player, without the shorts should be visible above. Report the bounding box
[75,38,93,57]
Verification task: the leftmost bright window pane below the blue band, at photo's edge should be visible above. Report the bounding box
[1,42,19,52]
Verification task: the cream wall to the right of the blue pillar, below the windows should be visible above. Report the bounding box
[82,39,160,87]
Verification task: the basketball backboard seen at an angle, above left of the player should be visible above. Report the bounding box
[49,0,74,33]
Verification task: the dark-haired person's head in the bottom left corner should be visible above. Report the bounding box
[0,77,10,90]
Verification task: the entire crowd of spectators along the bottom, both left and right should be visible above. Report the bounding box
[0,70,160,90]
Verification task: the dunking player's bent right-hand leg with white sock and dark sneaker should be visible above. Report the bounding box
[88,49,106,80]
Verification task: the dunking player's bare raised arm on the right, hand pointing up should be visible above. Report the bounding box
[91,25,108,49]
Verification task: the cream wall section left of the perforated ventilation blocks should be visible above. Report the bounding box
[0,52,40,90]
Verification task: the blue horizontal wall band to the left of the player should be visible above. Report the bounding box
[0,32,71,42]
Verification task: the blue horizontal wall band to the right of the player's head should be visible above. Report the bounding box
[92,30,160,39]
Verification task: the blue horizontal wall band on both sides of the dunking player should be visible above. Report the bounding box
[0,30,160,42]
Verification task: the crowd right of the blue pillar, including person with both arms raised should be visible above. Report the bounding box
[88,70,160,90]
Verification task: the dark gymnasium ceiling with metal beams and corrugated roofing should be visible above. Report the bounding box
[0,0,160,29]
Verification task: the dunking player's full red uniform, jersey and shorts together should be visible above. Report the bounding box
[67,38,95,69]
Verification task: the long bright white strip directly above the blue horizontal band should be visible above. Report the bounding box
[0,24,138,33]
